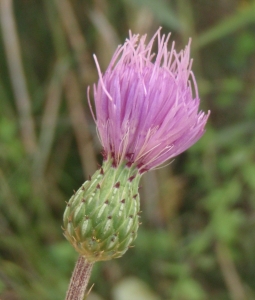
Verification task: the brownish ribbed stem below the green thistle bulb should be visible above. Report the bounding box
[65,255,93,300]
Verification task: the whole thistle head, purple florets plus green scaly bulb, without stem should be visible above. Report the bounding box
[64,29,209,262]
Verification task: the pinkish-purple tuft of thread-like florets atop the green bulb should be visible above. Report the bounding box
[88,29,210,172]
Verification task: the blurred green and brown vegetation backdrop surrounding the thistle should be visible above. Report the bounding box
[0,0,255,300]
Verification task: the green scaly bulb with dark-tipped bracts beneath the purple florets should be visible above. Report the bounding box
[64,159,141,262]
